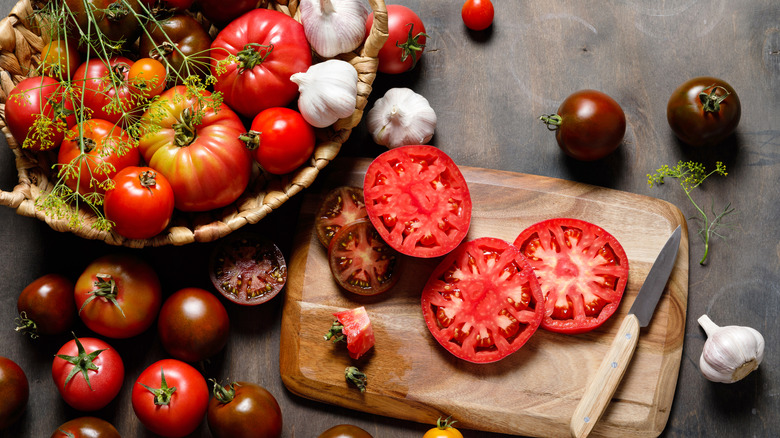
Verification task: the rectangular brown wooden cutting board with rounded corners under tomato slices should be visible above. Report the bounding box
[280,159,688,437]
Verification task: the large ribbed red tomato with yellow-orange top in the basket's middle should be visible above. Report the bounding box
[138,85,252,211]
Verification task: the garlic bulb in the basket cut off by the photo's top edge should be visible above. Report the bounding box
[300,0,370,58]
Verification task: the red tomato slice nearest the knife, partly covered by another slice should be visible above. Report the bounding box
[514,218,628,334]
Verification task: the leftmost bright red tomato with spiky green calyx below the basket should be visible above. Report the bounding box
[51,336,125,411]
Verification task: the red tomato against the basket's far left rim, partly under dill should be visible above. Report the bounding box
[5,76,76,151]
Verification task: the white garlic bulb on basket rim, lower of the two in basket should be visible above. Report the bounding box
[290,59,358,128]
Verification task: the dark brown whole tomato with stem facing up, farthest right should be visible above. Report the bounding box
[666,76,742,146]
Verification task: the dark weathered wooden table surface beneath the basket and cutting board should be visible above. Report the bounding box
[0,0,780,438]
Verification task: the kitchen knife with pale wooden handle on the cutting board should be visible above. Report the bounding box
[570,226,682,438]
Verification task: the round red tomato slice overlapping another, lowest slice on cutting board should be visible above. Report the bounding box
[422,237,544,363]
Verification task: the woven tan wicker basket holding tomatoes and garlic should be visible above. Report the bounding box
[0,0,388,248]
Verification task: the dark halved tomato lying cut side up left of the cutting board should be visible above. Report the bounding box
[209,232,287,306]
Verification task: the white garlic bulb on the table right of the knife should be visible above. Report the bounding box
[699,315,764,383]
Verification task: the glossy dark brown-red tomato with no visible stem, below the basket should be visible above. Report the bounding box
[157,287,230,362]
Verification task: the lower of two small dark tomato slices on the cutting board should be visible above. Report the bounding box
[328,219,401,295]
